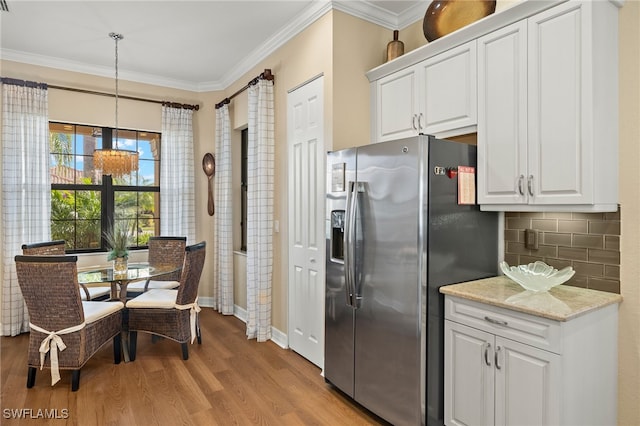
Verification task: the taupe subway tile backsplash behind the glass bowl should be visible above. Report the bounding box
[504,209,620,293]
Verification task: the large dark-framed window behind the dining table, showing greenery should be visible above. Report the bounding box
[49,122,161,252]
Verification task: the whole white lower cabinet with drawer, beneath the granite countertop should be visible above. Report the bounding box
[444,296,617,426]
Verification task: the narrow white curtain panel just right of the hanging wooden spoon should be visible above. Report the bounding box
[213,105,233,315]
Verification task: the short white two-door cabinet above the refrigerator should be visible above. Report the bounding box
[371,40,477,142]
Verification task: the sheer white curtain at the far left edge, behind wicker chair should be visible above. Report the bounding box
[1,79,51,336]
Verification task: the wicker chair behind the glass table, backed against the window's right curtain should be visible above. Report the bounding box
[127,237,187,296]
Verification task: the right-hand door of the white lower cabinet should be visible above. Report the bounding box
[494,337,561,426]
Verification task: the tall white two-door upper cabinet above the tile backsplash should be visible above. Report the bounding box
[478,1,618,211]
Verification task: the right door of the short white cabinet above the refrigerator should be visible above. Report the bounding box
[418,40,478,134]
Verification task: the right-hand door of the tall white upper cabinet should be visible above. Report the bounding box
[528,2,597,204]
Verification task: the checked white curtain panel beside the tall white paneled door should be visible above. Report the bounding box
[247,80,274,342]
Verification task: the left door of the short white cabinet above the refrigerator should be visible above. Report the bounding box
[374,67,418,142]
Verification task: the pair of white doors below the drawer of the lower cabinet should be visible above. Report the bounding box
[445,321,561,425]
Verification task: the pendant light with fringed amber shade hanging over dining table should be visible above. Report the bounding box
[93,33,138,177]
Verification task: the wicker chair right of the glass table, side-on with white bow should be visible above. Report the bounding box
[127,241,206,361]
